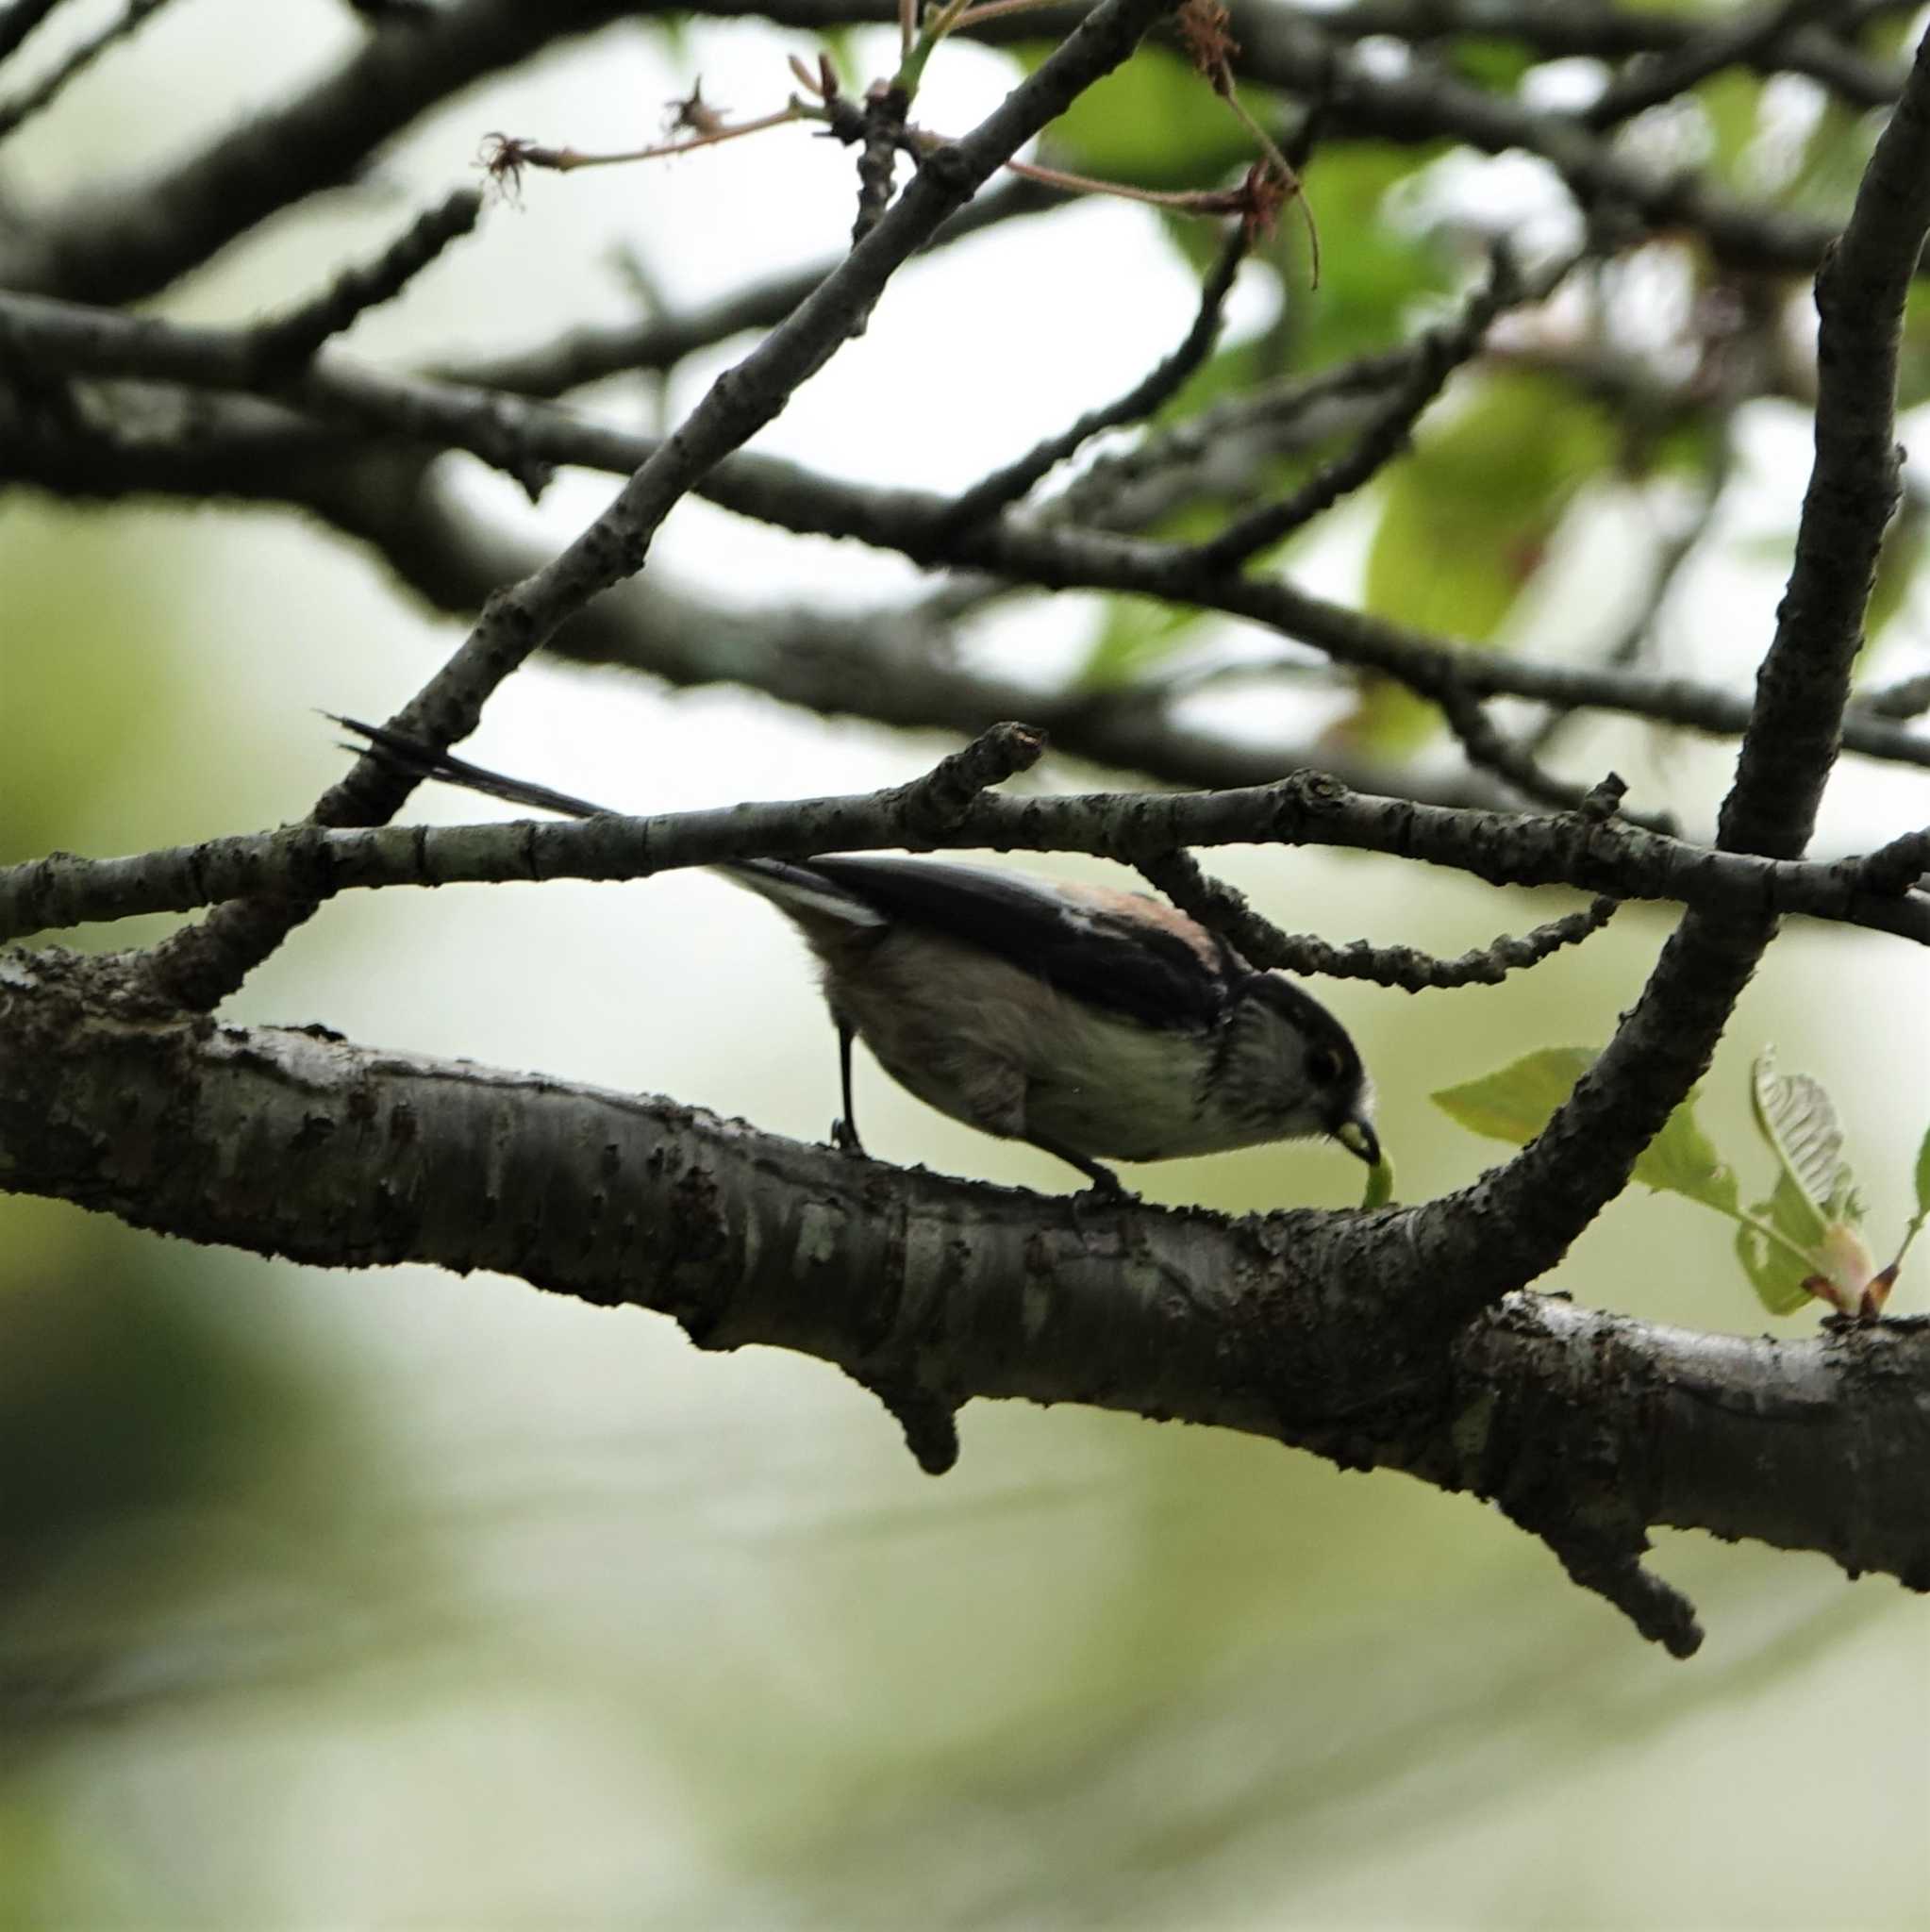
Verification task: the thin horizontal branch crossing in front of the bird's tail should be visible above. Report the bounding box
[15,771,1930,958]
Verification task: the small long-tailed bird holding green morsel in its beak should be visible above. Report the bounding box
[336,719,1381,1194]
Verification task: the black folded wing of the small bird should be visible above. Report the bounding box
[802,856,1244,1025]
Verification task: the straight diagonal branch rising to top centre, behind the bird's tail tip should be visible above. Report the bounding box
[121,0,1167,1008]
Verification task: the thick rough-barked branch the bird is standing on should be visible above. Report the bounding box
[0,955,1930,1652]
